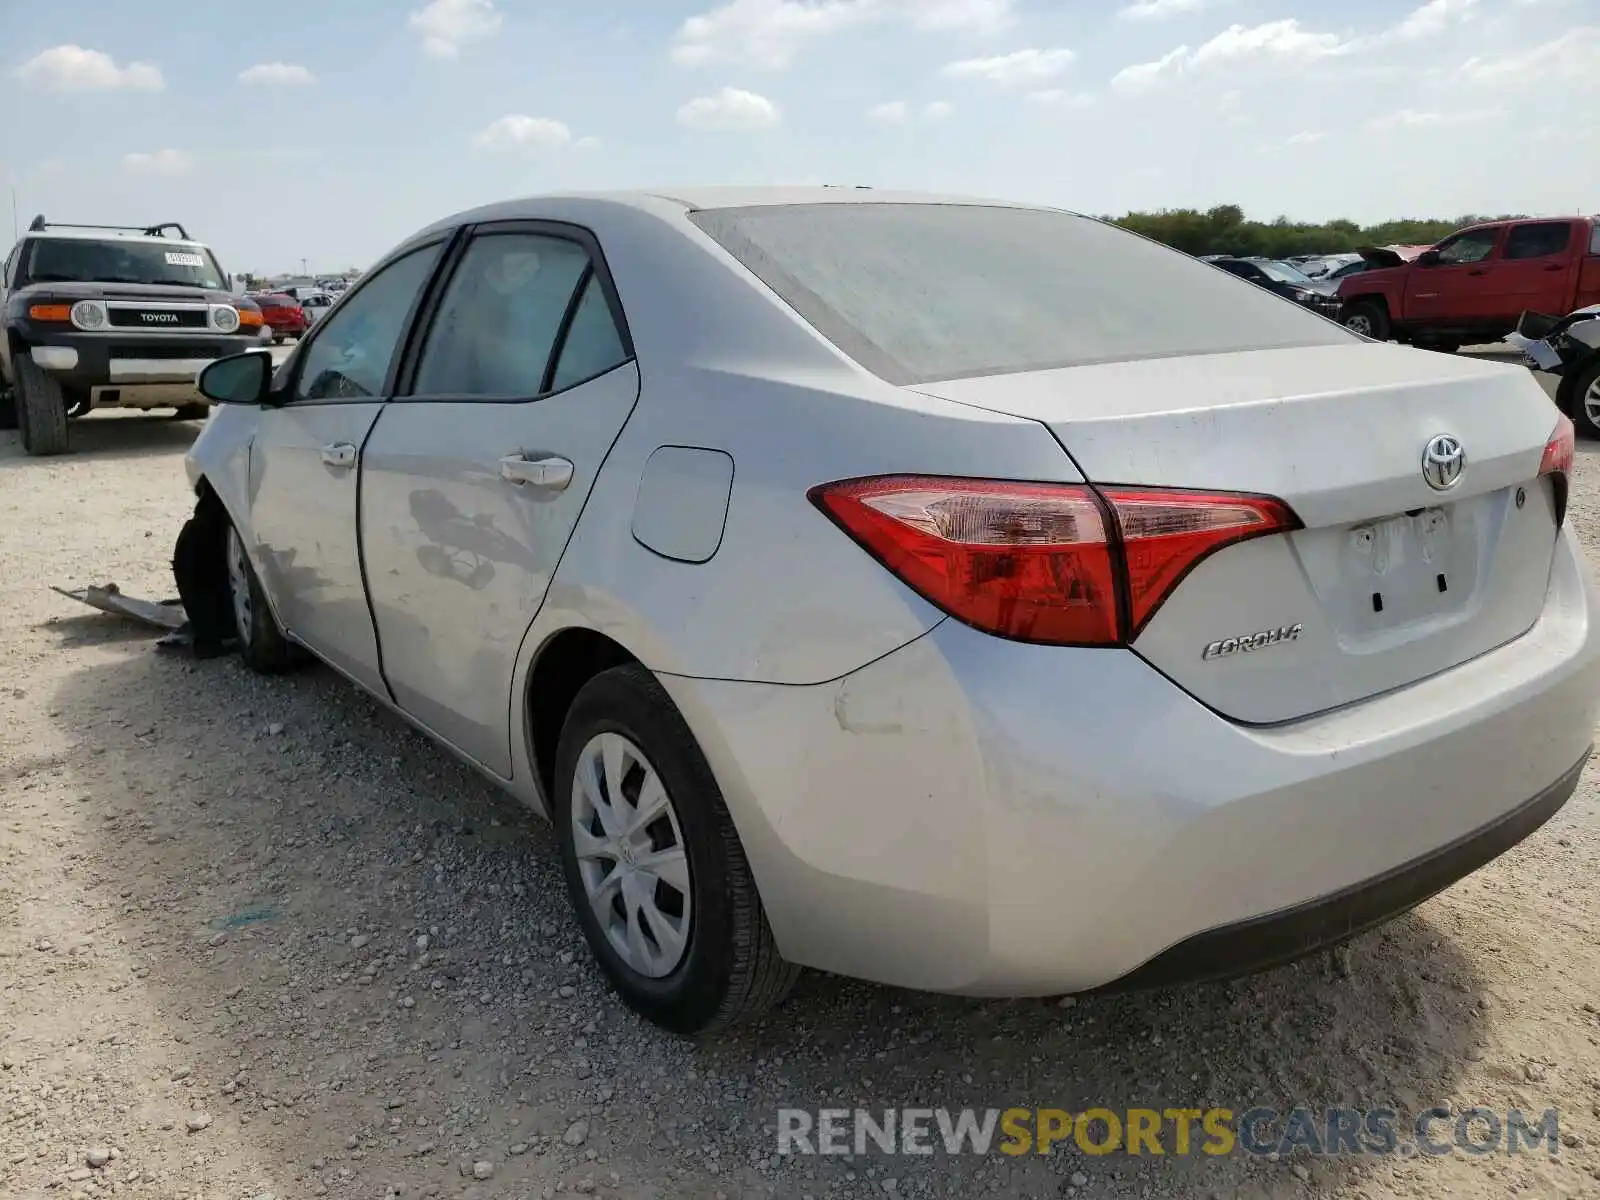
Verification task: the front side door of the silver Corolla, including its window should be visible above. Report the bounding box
[248,243,440,694]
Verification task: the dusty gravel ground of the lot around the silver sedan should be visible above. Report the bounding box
[0,369,1600,1200]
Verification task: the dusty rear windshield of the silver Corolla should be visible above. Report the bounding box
[690,203,1360,384]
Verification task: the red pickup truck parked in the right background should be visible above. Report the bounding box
[1338,216,1600,350]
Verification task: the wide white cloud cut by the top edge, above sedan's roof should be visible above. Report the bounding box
[670,0,1014,70]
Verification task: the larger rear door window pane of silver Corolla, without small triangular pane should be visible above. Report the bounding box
[413,234,589,398]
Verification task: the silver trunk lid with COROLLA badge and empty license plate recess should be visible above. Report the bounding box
[917,344,1558,723]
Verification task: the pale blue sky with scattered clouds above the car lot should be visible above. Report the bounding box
[0,0,1600,270]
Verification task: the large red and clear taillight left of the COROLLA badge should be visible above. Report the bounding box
[808,475,1299,646]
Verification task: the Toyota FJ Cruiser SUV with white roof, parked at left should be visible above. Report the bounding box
[0,216,262,454]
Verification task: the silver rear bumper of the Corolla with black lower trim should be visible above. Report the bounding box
[662,531,1600,995]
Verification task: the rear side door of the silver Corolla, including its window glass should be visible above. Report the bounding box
[363,222,638,778]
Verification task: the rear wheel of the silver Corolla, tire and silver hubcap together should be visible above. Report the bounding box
[552,664,798,1034]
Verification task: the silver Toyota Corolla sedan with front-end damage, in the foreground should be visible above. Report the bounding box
[189,189,1600,1032]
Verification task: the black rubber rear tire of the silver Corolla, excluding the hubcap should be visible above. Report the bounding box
[552,664,800,1035]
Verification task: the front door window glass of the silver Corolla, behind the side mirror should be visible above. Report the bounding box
[294,243,438,400]
